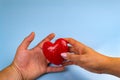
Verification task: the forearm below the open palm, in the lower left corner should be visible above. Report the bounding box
[0,65,22,80]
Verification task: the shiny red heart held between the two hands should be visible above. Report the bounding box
[43,38,68,65]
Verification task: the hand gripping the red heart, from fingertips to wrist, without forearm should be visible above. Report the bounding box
[61,38,110,73]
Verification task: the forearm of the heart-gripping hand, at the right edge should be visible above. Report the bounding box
[104,57,120,77]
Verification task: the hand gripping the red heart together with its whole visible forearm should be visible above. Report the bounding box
[61,38,120,77]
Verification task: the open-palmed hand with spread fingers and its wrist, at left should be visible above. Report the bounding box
[0,32,64,80]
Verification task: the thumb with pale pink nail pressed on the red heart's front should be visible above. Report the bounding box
[61,52,80,62]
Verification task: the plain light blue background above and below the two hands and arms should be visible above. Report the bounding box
[0,0,120,80]
